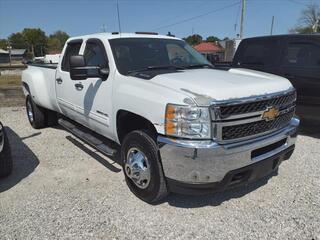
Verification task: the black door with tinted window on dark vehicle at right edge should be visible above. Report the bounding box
[279,37,320,106]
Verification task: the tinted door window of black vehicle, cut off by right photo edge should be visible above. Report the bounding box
[281,42,320,68]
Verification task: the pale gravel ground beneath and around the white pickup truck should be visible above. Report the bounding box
[0,107,320,240]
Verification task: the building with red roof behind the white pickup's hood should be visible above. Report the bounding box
[193,42,224,63]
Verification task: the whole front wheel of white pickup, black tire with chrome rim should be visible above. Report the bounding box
[121,130,168,203]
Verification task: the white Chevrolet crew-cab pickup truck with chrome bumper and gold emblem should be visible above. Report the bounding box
[22,33,299,203]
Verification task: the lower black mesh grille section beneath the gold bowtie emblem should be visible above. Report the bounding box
[222,109,294,141]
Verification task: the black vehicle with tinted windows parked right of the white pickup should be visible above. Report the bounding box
[231,34,320,121]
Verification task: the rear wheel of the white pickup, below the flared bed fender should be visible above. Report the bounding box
[26,95,47,129]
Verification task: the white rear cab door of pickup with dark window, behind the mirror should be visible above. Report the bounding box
[56,39,82,119]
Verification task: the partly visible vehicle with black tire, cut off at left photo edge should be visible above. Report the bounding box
[0,122,12,178]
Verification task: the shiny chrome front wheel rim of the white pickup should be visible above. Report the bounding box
[124,148,150,189]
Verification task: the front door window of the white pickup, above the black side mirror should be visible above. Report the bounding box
[83,40,108,68]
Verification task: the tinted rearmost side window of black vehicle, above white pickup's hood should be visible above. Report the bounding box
[235,39,278,67]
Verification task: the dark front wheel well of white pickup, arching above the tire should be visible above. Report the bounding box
[117,110,157,143]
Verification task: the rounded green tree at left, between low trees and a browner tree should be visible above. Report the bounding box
[22,28,47,56]
